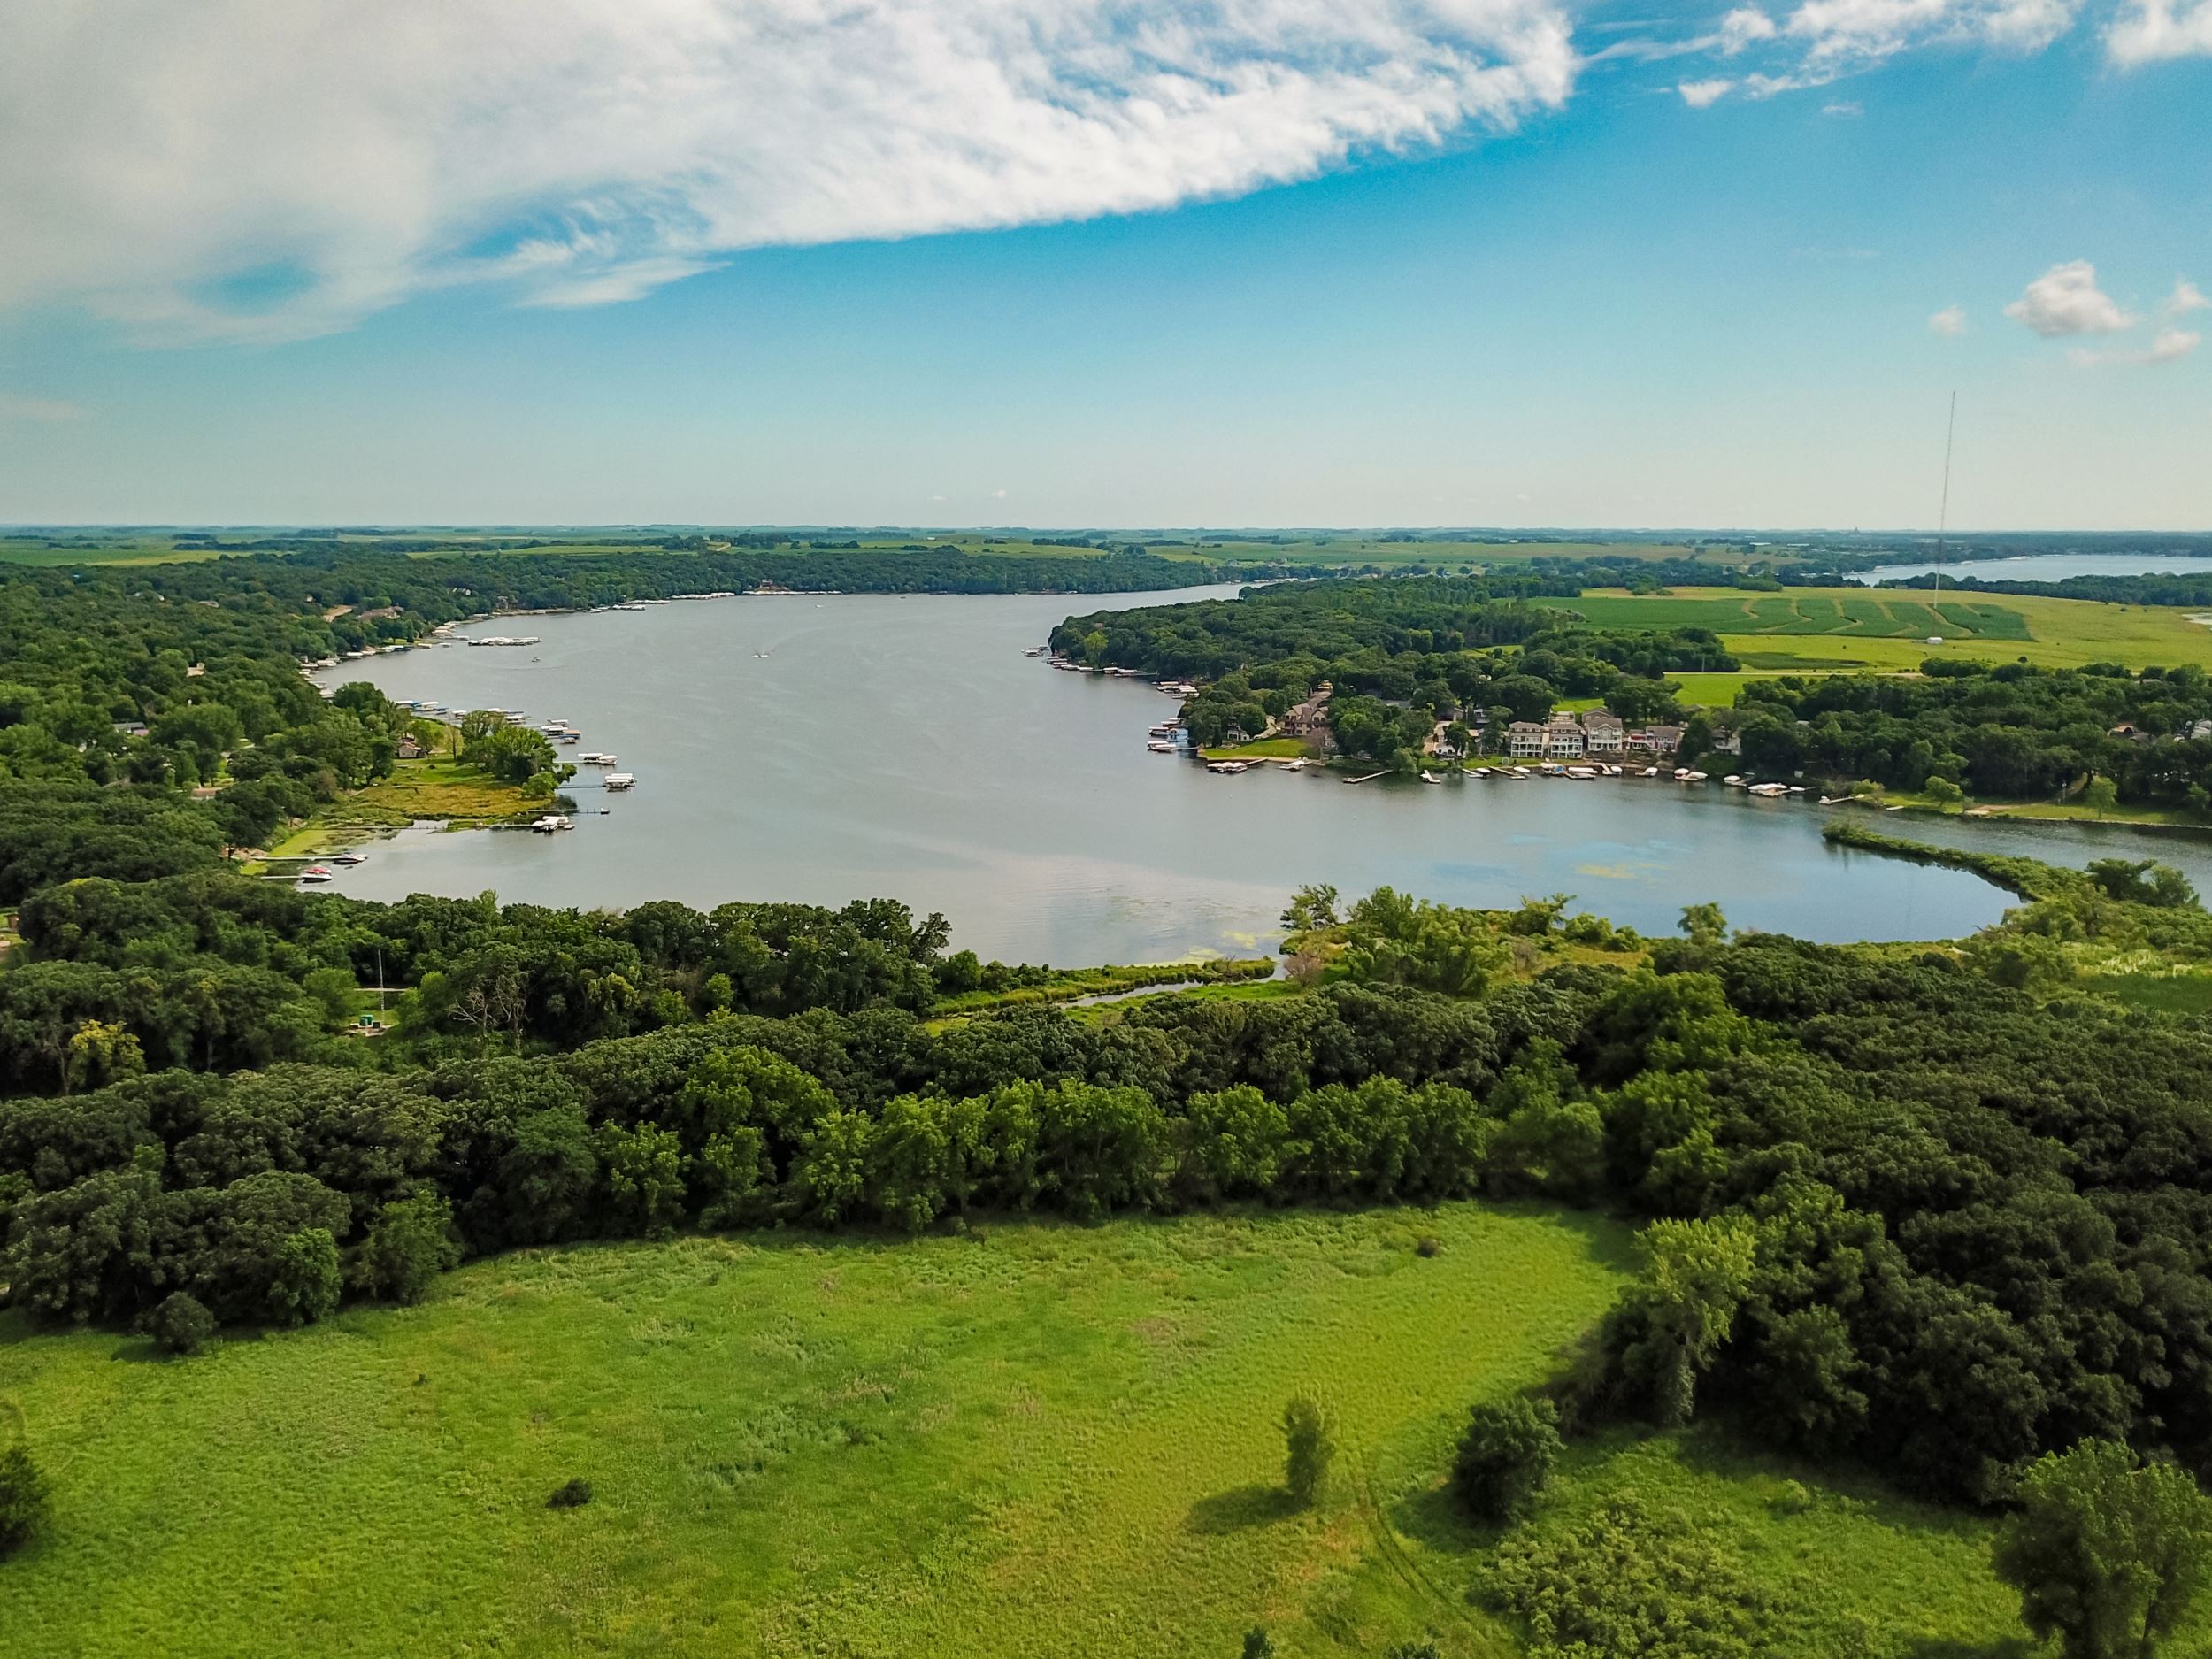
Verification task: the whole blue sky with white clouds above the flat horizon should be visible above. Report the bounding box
[0,0,2212,529]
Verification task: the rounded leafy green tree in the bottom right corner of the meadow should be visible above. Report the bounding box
[1991,1440,2212,1659]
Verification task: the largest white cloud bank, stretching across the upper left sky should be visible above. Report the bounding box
[0,0,1579,339]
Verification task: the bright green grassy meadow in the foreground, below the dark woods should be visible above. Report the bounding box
[0,1203,2008,1659]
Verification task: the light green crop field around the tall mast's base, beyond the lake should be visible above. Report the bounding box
[1533,588,2212,672]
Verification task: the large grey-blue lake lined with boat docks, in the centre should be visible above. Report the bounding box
[307,588,2212,967]
